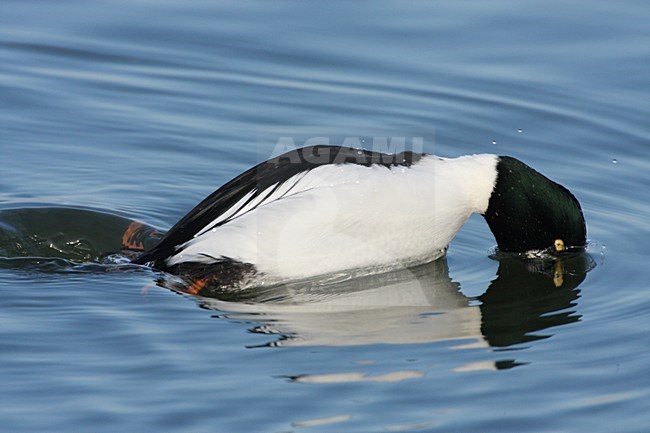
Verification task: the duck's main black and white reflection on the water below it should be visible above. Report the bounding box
[190,254,591,347]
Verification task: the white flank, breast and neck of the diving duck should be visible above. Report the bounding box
[166,155,498,279]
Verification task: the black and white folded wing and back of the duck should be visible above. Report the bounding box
[135,146,422,269]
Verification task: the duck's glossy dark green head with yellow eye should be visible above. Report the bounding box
[483,156,587,253]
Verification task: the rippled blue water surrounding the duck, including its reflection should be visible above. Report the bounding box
[0,0,650,432]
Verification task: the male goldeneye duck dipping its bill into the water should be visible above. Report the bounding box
[134,145,586,292]
